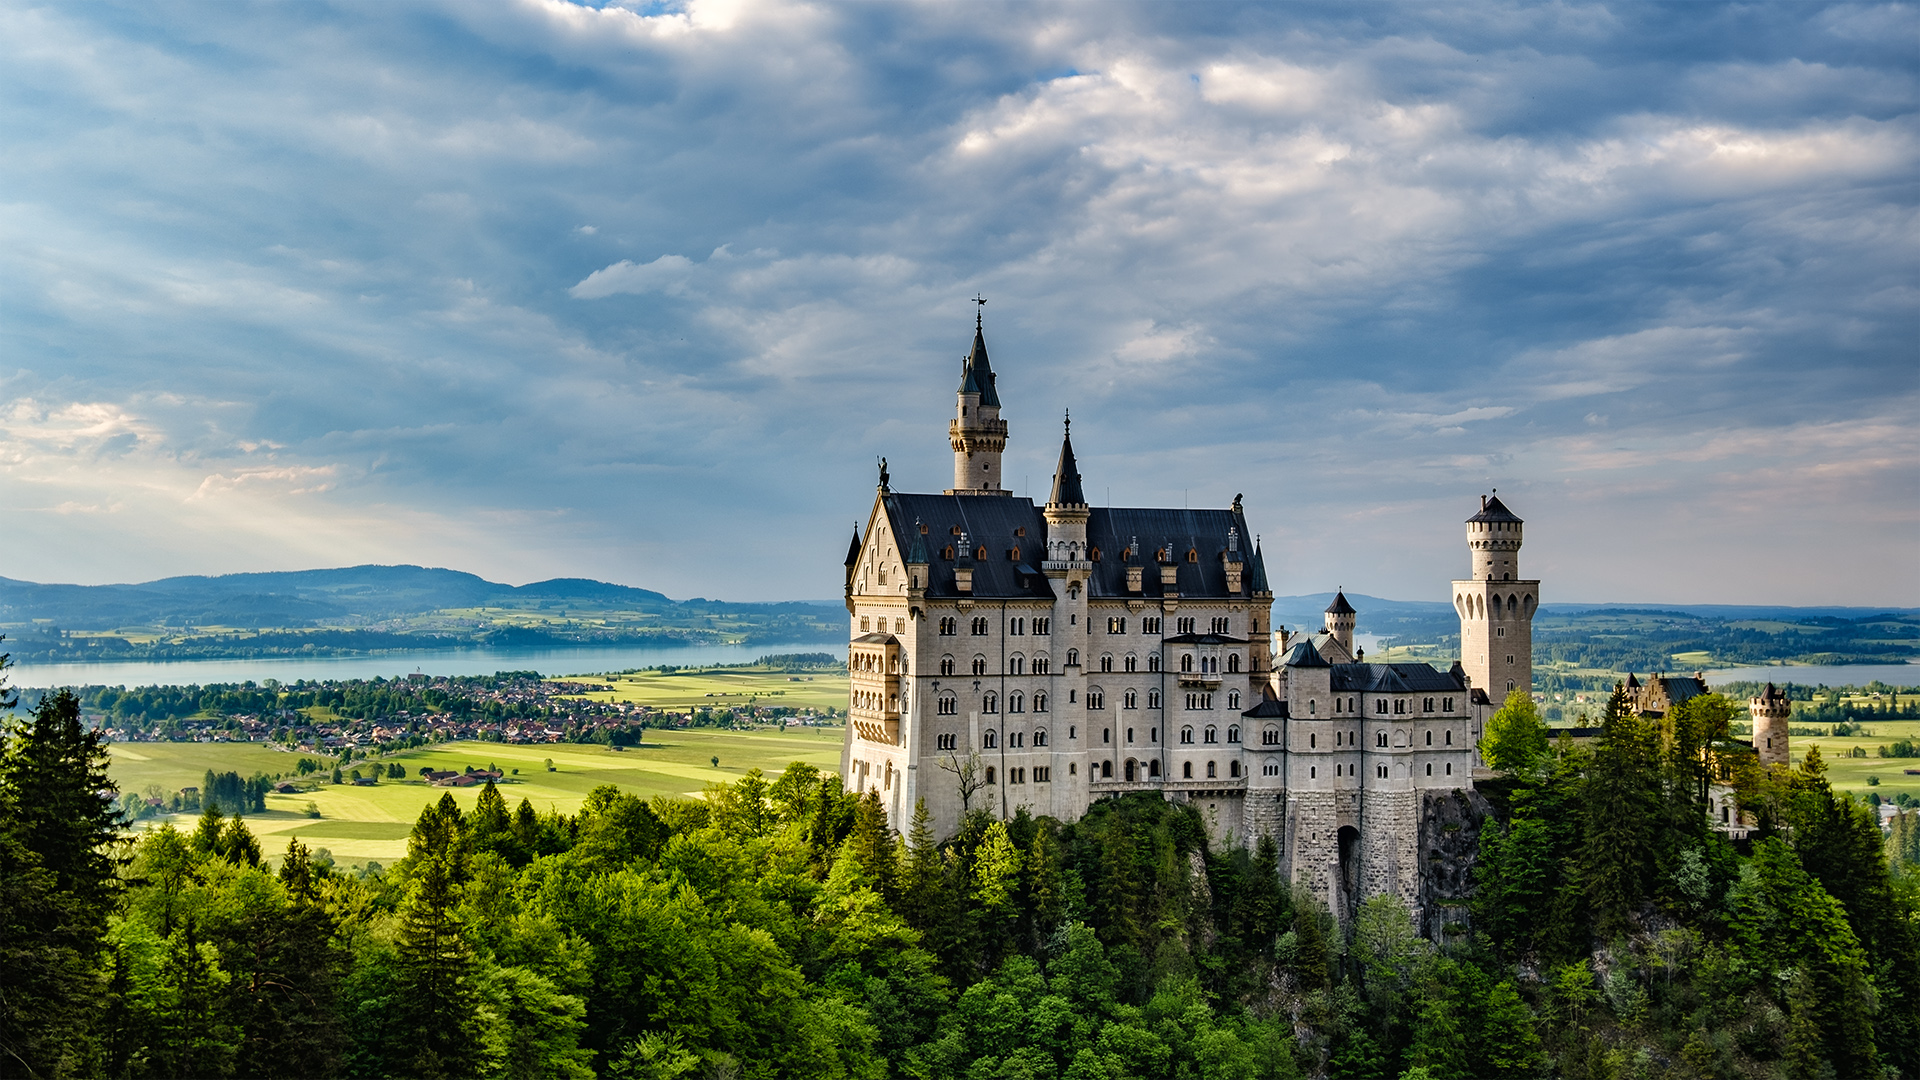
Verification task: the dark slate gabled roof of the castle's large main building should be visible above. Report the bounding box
[883,492,1252,599]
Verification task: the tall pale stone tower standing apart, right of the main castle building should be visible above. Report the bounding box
[1453,494,1540,705]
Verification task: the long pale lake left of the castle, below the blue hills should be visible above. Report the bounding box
[6,642,847,686]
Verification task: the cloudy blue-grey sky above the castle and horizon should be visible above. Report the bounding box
[0,0,1920,605]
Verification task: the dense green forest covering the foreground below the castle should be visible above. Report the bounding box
[0,676,1920,1080]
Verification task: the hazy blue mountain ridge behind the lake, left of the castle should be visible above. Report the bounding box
[0,565,833,630]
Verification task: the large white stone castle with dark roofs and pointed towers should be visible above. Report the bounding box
[841,321,1540,913]
